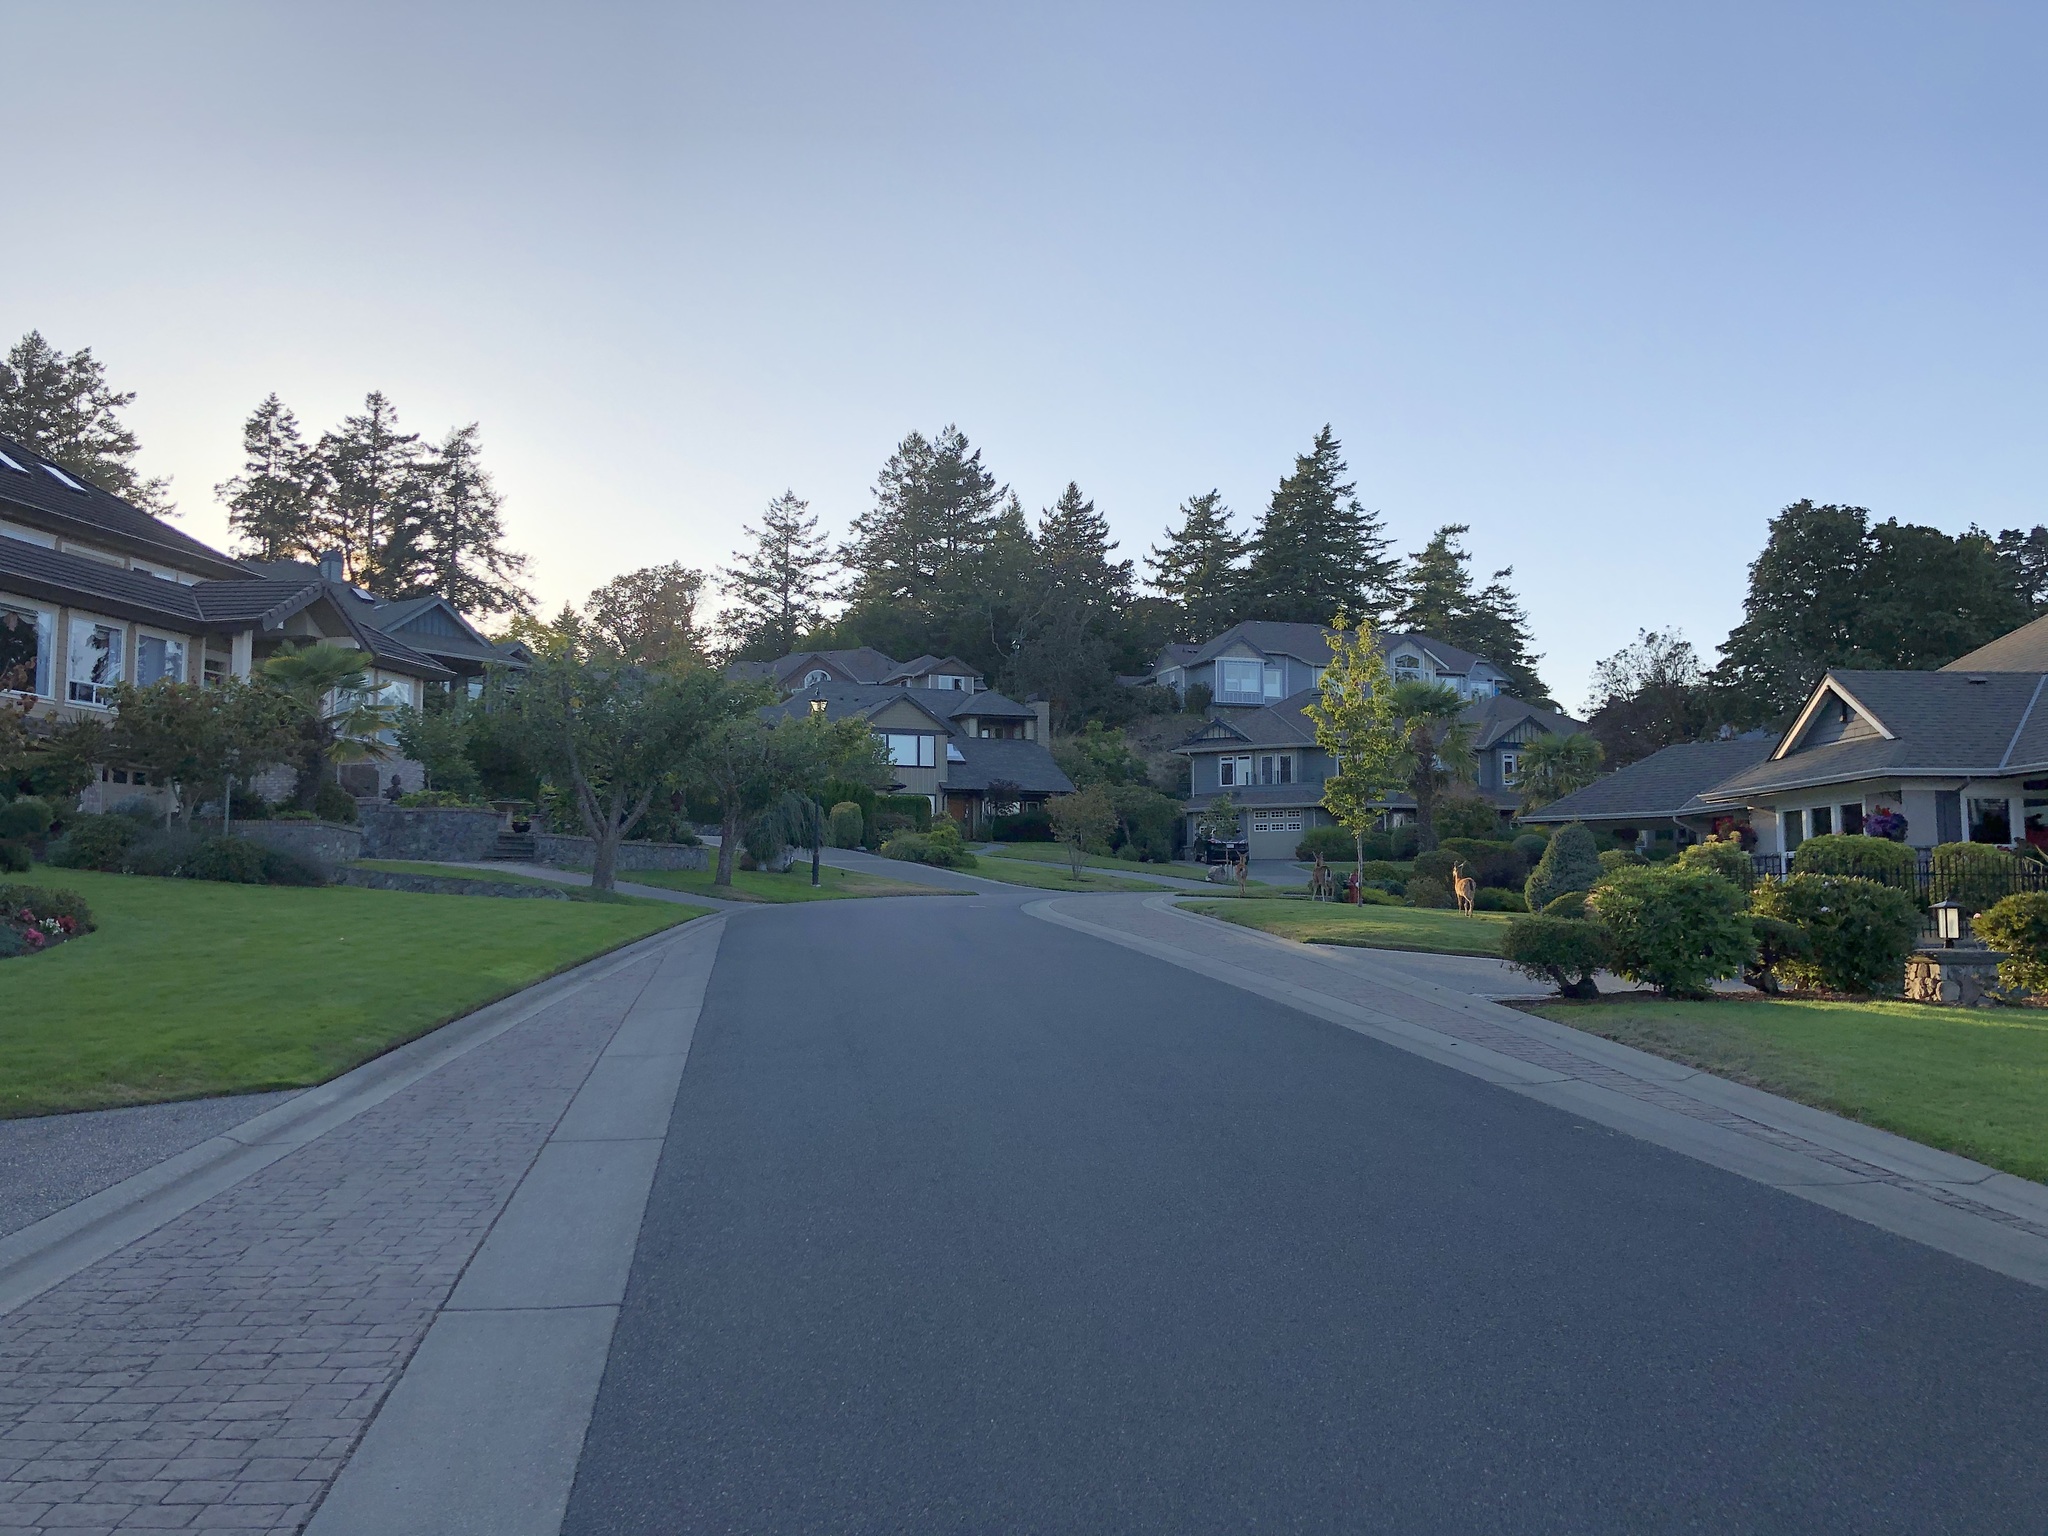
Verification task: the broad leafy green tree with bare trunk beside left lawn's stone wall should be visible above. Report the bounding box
[512,645,741,891]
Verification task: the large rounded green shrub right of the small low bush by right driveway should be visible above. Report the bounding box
[1587,866,1757,997]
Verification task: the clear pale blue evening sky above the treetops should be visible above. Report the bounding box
[0,0,2048,702]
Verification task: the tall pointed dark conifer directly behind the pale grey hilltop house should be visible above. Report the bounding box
[1241,426,1397,625]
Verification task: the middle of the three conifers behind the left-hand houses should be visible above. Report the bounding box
[313,389,430,596]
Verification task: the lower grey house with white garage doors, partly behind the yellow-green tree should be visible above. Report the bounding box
[1176,688,1585,858]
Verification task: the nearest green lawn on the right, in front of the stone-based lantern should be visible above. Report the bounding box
[1528,997,2048,1182]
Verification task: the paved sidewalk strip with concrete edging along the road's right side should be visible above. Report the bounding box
[1026,895,2048,1288]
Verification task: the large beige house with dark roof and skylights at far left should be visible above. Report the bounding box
[0,438,526,799]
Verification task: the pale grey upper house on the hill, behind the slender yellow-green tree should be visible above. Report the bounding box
[1143,618,1507,709]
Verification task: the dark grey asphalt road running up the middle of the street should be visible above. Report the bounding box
[565,899,2048,1536]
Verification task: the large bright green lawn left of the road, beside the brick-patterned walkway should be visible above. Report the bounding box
[0,868,705,1116]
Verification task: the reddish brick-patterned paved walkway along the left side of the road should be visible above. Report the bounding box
[0,918,723,1536]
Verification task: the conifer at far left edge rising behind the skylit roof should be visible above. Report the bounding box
[0,330,176,518]
